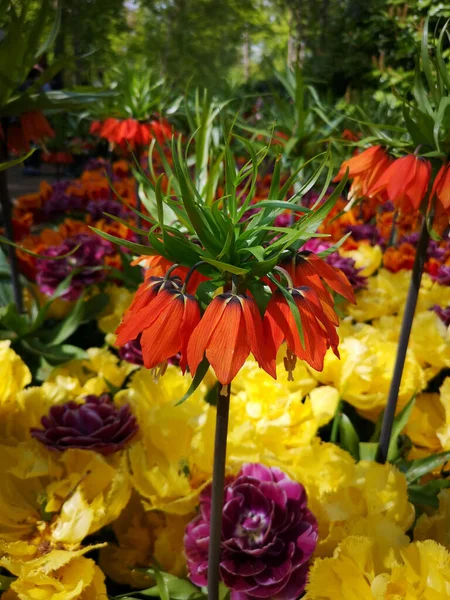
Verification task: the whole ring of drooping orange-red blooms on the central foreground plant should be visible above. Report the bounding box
[116,252,354,385]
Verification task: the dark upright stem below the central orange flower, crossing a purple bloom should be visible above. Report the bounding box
[208,385,230,600]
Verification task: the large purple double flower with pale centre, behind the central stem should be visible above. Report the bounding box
[184,464,317,600]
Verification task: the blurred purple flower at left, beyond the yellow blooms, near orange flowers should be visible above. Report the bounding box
[36,233,114,300]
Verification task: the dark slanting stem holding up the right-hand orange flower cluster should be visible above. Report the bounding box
[377,218,430,463]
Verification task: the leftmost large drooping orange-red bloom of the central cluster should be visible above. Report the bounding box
[116,277,200,373]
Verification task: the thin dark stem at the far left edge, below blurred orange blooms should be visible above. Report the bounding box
[0,125,23,313]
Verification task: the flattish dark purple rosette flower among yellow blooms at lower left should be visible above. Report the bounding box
[31,394,138,456]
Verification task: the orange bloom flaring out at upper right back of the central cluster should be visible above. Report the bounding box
[282,252,355,302]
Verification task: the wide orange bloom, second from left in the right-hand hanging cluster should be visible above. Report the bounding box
[367,154,431,212]
